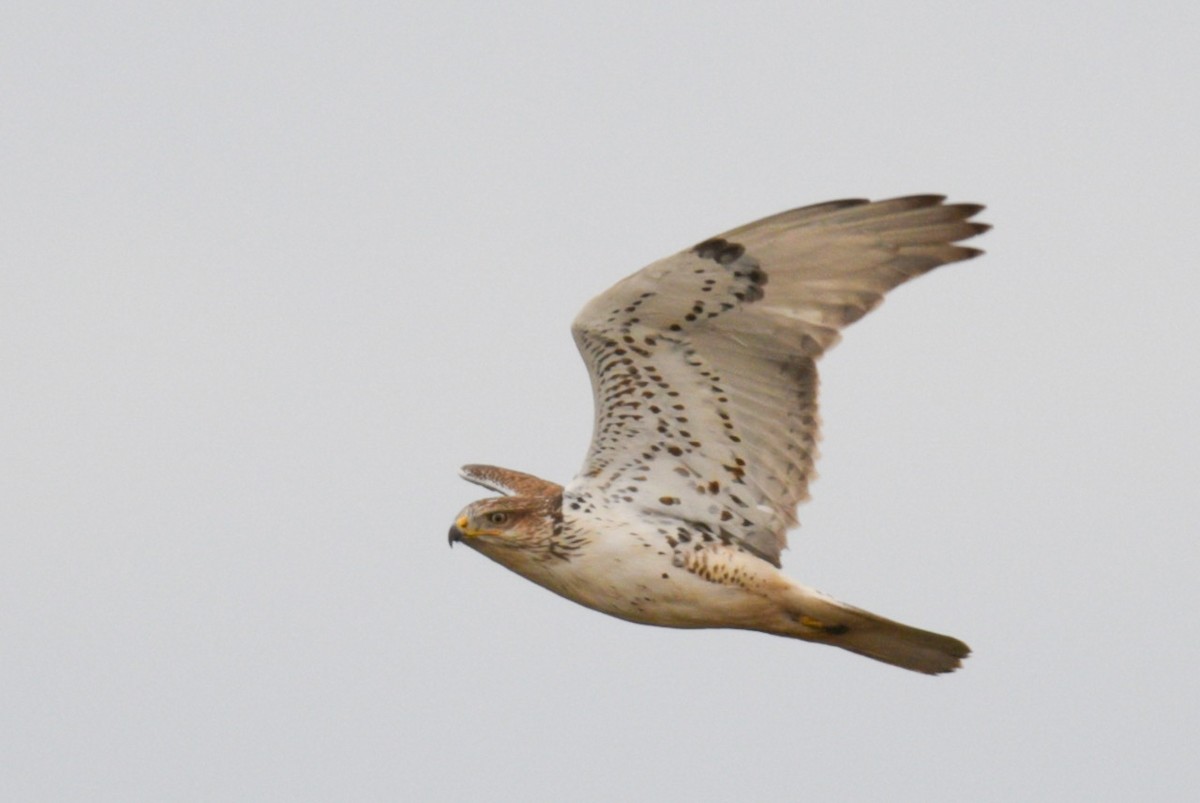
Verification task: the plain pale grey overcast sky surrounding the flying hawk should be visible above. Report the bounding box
[0,2,1200,801]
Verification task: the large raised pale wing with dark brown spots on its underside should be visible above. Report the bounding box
[566,196,988,565]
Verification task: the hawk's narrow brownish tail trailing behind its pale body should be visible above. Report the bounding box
[784,586,971,675]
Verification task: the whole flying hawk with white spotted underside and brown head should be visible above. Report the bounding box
[450,196,989,675]
